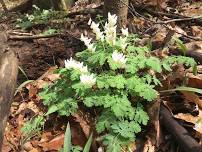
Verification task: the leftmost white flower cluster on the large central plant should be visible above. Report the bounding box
[65,58,88,73]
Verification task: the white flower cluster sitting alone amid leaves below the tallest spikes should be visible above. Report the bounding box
[112,50,127,68]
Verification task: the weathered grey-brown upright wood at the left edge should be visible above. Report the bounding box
[0,33,18,151]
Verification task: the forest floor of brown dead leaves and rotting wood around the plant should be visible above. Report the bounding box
[0,0,202,152]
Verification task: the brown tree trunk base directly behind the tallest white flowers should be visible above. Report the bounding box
[104,0,129,29]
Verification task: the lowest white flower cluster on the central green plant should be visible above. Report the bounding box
[80,74,96,86]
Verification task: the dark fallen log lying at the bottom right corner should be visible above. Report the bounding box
[160,105,202,152]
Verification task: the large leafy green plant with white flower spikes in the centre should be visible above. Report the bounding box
[41,13,196,152]
